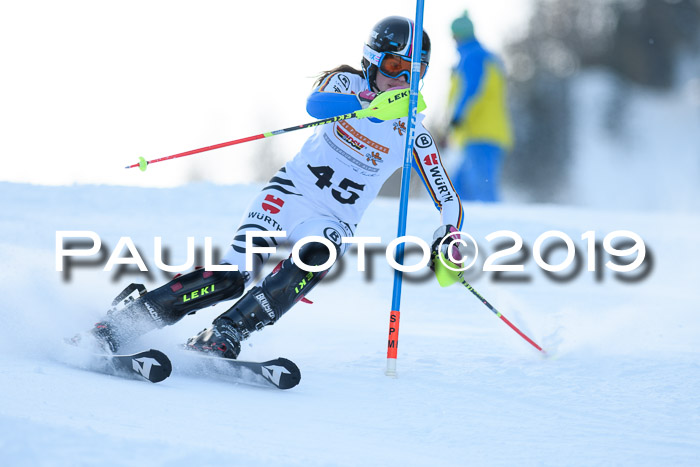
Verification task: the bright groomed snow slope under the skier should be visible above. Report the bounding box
[0,183,700,466]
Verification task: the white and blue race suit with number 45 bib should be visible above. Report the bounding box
[223,73,463,285]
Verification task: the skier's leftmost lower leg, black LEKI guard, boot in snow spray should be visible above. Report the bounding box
[84,269,245,352]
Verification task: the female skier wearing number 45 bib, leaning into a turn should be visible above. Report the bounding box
[86,16,462,358]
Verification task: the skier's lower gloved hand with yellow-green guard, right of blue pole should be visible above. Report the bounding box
[430,224,466,287]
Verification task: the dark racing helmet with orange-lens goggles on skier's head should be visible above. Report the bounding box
[362,16,430,92]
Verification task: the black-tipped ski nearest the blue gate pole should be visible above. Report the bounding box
[177,350,301,389]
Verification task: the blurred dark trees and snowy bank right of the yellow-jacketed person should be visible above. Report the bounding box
[505,0,700,211]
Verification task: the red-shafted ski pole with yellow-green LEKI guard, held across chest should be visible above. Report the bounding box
[125,89,426,172]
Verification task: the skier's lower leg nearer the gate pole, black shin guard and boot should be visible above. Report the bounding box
[186,239,338,358]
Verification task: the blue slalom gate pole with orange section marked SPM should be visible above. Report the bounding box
[386,0,424,377]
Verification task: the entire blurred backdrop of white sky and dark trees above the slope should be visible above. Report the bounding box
[0,0,700,212]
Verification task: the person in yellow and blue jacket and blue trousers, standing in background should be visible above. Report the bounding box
[448,11,513,202]
